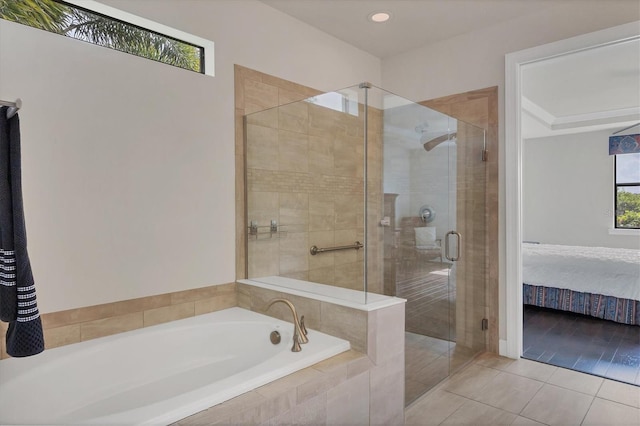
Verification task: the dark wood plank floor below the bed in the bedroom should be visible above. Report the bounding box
[522,305,640,386]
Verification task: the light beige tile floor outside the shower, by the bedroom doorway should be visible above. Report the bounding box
[405,353,640,426]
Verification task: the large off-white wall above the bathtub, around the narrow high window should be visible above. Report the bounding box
[0,0,380,312]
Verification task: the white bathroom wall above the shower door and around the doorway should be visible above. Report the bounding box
[382,0,640,339]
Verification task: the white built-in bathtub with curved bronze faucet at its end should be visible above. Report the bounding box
[0,308,350,425]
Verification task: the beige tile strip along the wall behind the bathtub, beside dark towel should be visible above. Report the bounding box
[0,283,237,359]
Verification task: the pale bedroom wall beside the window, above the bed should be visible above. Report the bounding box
[522,131,640,249]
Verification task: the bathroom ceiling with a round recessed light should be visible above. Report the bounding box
[262,0,573,58]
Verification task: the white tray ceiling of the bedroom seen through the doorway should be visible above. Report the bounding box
[522,38,640,138]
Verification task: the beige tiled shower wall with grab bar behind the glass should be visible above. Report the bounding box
[245,73,382,292]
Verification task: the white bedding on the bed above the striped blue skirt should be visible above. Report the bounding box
[522,243,640,300]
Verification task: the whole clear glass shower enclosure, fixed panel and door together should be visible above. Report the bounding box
[245,83,486,405]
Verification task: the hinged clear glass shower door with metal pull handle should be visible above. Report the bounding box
[380,93,486,405]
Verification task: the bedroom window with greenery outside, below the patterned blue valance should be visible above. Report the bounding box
[614,153,640,229]
